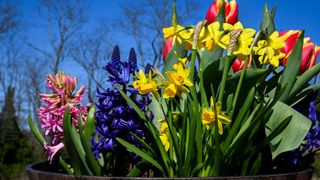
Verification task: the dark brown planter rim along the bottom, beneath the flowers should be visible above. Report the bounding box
[26,161,313,180]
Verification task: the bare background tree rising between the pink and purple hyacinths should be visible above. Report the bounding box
[70,26,112,102]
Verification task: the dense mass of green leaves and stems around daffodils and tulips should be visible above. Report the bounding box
[114,1,320,177]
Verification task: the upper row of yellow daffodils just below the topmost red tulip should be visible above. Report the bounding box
[163,22,296,67]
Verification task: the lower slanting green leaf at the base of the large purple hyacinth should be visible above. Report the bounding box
[117,138,163,172]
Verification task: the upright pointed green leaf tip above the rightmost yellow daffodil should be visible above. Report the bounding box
[260,4,276,36]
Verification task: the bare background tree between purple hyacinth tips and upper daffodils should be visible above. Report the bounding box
[114,0,199,67]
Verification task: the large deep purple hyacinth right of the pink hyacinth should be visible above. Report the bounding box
[90,46,153,160]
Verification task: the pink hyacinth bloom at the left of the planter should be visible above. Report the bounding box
[38,72,90,163]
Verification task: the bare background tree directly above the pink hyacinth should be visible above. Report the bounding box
[26,0,88,74]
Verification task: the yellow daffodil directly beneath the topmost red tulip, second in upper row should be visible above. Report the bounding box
[202,22,223,51]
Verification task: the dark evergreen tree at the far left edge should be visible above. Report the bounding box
[0,87,43,179]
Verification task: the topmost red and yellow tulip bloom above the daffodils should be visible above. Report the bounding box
[206,0,238,25]
